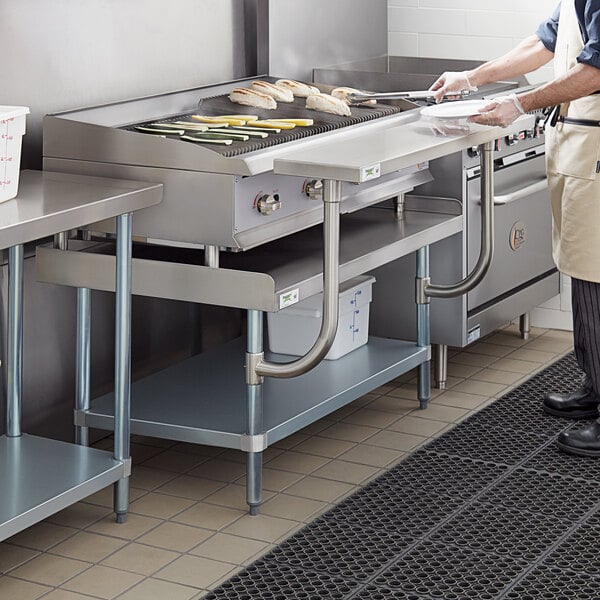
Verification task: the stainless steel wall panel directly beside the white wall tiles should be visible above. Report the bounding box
[266,0,388,81]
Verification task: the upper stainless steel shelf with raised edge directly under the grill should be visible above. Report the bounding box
[37,208,463,312]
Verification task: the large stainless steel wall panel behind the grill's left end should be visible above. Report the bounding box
[0,0,251,168]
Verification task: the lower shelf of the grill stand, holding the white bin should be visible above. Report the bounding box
[77,338,429,449]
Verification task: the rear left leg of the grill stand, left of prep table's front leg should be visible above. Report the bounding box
[75,288,92,446]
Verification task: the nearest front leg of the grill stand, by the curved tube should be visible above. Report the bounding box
[246,310,263,515]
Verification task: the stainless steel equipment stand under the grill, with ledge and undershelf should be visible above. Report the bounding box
[38,115,510,513]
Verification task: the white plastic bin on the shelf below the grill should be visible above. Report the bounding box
[267,275,375,360]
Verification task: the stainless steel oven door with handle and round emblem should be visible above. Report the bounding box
[466,155,555,310]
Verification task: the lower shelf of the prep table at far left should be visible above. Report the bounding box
[0,435,125,540]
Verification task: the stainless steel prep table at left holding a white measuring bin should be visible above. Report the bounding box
[0,171,162,540]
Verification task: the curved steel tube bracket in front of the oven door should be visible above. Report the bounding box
[424,142,494,298]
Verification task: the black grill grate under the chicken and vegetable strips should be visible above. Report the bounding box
[125,91,403,157]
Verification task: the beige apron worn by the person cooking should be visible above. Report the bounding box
[546,0,600,282]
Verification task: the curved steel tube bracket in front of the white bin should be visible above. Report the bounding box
[256,180,342,378]
